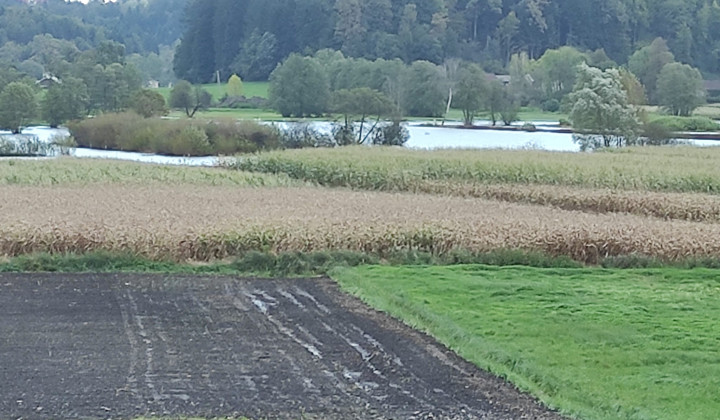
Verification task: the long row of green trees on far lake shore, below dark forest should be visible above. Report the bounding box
[262,42,704,125]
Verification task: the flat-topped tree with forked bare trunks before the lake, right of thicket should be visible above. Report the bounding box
[332,87,392,144]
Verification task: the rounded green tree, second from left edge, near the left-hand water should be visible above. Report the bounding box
[40,77,90,128]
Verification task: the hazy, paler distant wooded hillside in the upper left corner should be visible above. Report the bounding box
[0,0,185,83]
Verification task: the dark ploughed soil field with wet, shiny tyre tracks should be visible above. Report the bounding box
[0,274,560,419]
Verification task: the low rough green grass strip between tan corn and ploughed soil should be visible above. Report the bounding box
[0,250,580,277]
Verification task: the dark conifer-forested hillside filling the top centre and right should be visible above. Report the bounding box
[175,0,720,82]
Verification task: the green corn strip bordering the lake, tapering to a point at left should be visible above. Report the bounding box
[228,147,720,194]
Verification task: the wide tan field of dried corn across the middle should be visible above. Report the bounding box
[0,185,720,263]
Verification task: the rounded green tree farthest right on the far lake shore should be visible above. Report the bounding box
[656,63,705,116]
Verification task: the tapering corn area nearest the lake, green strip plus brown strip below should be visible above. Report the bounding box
[229,147,720,221]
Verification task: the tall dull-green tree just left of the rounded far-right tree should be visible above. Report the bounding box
[628,38,675,104]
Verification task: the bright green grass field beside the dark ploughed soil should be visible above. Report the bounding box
[332,266,720,420]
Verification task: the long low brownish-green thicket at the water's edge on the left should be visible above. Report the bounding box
[69,113,282,156]
